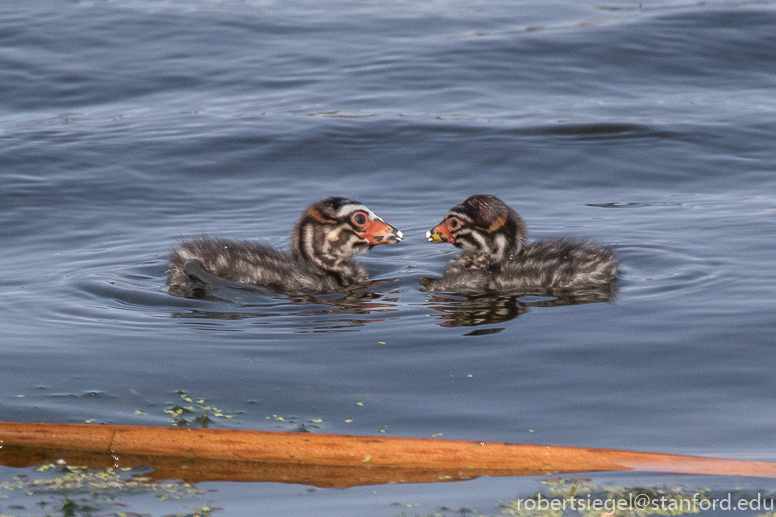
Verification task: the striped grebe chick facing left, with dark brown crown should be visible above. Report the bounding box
[426,195,617,293]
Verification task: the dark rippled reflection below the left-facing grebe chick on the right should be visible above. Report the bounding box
[421,279,616,326]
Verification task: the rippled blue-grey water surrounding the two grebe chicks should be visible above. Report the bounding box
[0,0,776,515]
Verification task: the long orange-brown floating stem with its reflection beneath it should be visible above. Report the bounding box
[0,422,776,487]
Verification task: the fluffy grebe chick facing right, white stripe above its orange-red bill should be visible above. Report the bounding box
[167,197,403,292]
